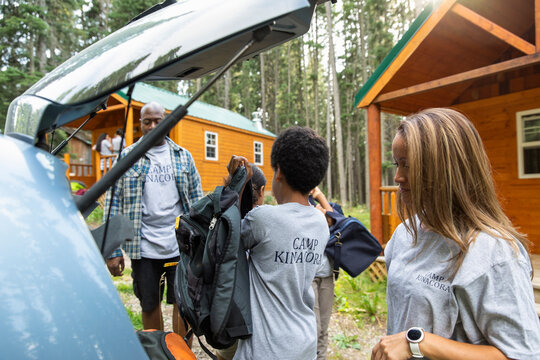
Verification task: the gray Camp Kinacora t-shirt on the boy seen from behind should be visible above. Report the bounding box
[234,203,329,360]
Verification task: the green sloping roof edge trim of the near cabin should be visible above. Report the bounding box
[354,3,435,107]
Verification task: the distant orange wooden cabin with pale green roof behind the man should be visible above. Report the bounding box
[67,83,275,192]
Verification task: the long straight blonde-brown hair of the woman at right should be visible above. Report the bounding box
[397,108,529,274]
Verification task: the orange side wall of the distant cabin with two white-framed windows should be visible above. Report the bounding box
[172,116,274,192]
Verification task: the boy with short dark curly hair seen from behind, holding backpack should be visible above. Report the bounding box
[229,127,330,360]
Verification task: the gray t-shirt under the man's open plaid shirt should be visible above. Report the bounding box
[141,143,181,259]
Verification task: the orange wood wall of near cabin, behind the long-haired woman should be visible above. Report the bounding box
[456,88,540,254]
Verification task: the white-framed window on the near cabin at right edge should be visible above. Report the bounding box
[516,109,540,179]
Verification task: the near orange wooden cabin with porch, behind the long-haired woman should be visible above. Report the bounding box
[356,0,540,254]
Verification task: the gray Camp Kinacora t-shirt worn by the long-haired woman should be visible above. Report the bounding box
[385,224,540,359]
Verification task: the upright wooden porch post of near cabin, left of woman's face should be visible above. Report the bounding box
[367,104,383,242]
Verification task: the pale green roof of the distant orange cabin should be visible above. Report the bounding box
[117,82,276,137]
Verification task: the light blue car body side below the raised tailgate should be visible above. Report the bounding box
[0,135,147,359]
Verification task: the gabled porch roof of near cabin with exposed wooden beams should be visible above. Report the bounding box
[355,0,540,114]
